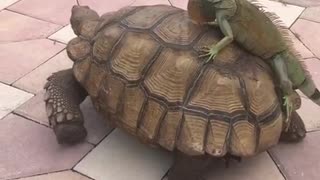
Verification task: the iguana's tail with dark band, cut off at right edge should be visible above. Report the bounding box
[298,76,320,106]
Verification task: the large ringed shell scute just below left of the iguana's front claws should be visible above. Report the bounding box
[144,48,200,104]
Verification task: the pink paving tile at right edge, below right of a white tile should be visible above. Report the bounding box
[291,19,320,58]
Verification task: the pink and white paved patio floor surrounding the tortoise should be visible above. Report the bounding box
[0,0,320,180]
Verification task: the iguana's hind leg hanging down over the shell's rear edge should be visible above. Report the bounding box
[273,54,294,131]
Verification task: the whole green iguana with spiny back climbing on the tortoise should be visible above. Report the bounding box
[188,0,320,130]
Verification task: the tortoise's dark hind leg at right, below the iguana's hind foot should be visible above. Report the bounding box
[280,111,307,142]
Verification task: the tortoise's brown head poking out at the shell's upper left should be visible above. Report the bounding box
[70,5,99,36]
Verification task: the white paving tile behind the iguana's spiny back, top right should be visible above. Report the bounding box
[257,0,304,27]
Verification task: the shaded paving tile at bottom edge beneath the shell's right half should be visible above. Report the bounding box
[205,152,285,180]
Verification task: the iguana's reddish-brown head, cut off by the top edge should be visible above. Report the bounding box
[188,0,223,24]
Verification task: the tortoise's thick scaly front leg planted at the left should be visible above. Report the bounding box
[44,69,87,144]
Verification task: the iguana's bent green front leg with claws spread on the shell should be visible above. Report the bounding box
[200,11,233,62]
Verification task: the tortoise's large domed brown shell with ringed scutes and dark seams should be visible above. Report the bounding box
[70,5,283,156]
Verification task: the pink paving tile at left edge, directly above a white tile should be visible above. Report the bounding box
[0,39,65,84]
